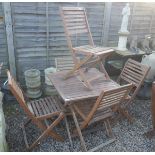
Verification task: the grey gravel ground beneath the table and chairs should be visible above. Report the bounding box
[4,99,155,152]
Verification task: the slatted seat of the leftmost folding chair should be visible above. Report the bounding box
[27,96,64,117]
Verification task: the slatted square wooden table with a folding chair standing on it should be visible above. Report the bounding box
[48,68,120,151]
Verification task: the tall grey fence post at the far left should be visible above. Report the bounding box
[3,2,16,79]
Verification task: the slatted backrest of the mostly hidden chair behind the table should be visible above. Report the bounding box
[55,57,74,71]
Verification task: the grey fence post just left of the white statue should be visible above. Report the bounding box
[101,2,112,46]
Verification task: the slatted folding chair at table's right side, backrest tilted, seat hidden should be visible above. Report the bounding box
[117,59,150,121]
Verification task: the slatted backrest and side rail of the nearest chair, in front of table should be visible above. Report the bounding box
[81,84,132,129]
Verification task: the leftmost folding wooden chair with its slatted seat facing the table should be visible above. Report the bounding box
[7,71,70,150]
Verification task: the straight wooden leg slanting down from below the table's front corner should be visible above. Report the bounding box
[70,106,87,151]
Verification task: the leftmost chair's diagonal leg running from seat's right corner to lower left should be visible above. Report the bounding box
[28,114,64,150]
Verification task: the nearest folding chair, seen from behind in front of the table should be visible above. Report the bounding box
[71,84,132,151]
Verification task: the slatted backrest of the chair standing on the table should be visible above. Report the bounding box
[60,7,94,49]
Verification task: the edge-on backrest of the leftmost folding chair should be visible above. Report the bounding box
[7,71,33,116]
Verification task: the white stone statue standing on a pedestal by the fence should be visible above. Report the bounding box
[120,3,130,32]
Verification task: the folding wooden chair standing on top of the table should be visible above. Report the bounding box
[60,7,114,89]
